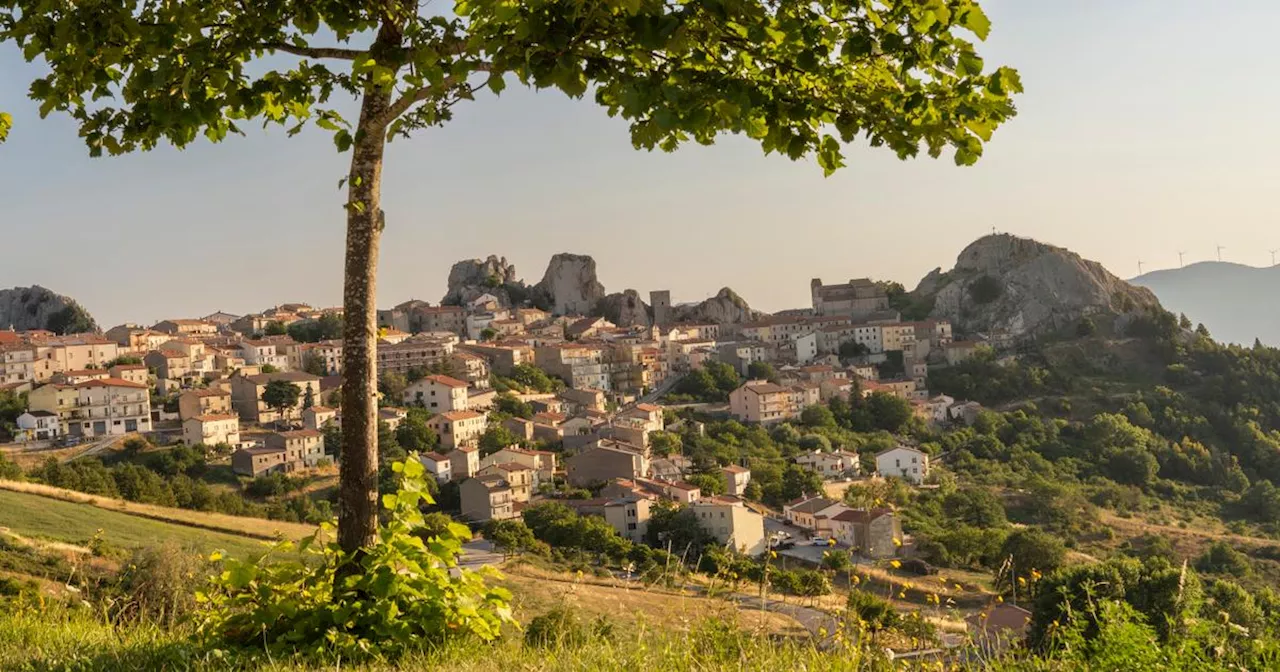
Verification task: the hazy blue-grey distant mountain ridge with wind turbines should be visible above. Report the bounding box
[1129,261,1280,346]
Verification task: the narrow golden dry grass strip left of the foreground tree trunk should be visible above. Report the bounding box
[0,480,316,540]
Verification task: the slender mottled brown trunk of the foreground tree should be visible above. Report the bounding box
[338,87,390,554]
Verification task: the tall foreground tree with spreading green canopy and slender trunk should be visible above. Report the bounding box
[0,0,1021,552]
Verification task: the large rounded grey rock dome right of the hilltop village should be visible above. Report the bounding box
[913,234,1160,337]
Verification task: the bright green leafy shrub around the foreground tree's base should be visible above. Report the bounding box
[197,456,512,659]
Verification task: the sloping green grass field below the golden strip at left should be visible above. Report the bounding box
[0,490,266,557]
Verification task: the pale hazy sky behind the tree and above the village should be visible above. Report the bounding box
[0,0,1280,328]
